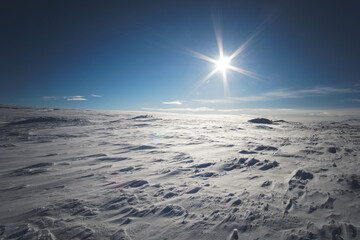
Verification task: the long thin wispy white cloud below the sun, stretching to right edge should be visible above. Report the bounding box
[193,87,360,104]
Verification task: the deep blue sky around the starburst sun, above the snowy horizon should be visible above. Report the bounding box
[0,0,360,118]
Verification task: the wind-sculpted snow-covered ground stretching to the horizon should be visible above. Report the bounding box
[0,106,360,240]
